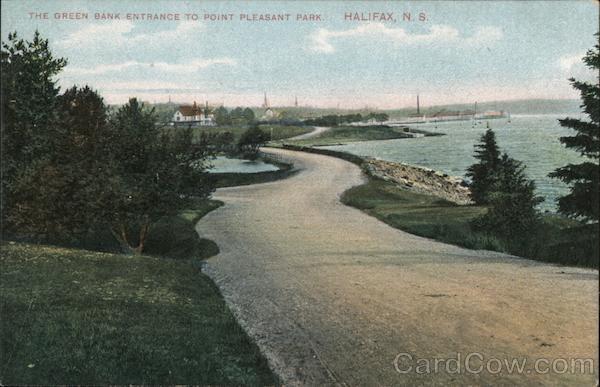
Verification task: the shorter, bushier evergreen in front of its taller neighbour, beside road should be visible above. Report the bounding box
[474,153,544,252]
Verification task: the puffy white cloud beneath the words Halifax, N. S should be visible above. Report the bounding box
[309,23,502,53]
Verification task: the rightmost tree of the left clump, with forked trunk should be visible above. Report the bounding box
[107,98,212,254]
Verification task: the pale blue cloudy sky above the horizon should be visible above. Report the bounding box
[2,0,598,108]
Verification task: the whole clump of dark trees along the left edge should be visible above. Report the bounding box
[2,33,216,253]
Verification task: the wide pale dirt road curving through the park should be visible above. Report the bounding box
[197,149,598,385]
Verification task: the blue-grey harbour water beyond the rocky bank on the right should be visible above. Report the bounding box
[325,114,585,212]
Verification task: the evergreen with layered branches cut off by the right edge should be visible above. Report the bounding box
[550,34,600,223]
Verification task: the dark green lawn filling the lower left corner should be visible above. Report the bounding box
[0,243,274,385]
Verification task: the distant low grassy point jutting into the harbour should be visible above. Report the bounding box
[286,125,438,146]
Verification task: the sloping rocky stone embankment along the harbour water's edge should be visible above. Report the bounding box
[363,158,472,204]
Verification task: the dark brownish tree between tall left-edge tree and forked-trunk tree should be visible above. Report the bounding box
[11,86,112,241]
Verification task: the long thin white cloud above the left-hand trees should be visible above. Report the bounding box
[65,58,236,76]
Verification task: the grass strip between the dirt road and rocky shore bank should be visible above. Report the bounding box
[342,178,598,268]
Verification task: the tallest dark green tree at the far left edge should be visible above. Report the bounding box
[0,31,67,229]
